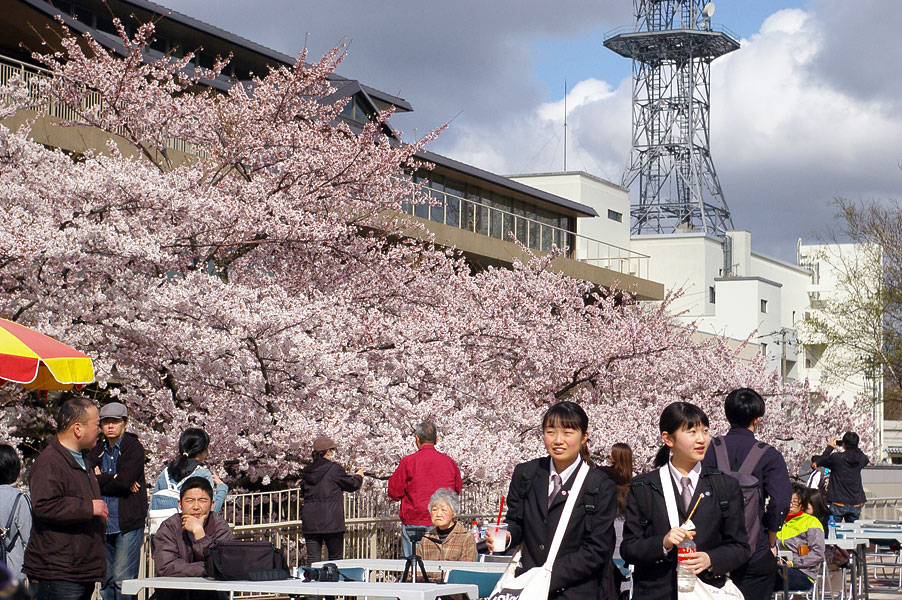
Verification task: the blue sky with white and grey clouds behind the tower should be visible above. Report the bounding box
[160,0,902,262]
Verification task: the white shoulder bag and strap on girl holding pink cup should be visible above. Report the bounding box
[489,462,589,600]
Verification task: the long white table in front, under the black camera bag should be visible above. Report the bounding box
[122,577,479,600]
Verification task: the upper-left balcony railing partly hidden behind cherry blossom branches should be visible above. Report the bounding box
[0,54,205,156]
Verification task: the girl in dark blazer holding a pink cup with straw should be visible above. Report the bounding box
[487,401,617,600]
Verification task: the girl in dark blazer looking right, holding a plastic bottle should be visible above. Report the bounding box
[620,402,749,600]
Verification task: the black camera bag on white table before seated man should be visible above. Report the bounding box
[206,541,290,581]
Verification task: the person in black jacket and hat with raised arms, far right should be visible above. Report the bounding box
[818,431,868,523]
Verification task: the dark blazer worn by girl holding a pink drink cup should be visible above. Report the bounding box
[505,456,617,600]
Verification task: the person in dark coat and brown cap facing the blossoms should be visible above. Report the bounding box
[301,435,363,565]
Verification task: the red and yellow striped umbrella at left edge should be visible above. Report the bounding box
[0,319,94,390]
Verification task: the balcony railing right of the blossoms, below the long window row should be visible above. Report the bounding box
[404,188,649,279]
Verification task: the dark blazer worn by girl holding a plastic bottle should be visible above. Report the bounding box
[620,467,750,600]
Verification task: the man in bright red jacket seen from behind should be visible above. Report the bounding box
[388,421,461,557]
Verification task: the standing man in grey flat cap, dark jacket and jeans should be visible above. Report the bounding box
[88,402,147,600]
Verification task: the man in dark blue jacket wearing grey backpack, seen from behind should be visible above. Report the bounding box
[703,388,792,600]
